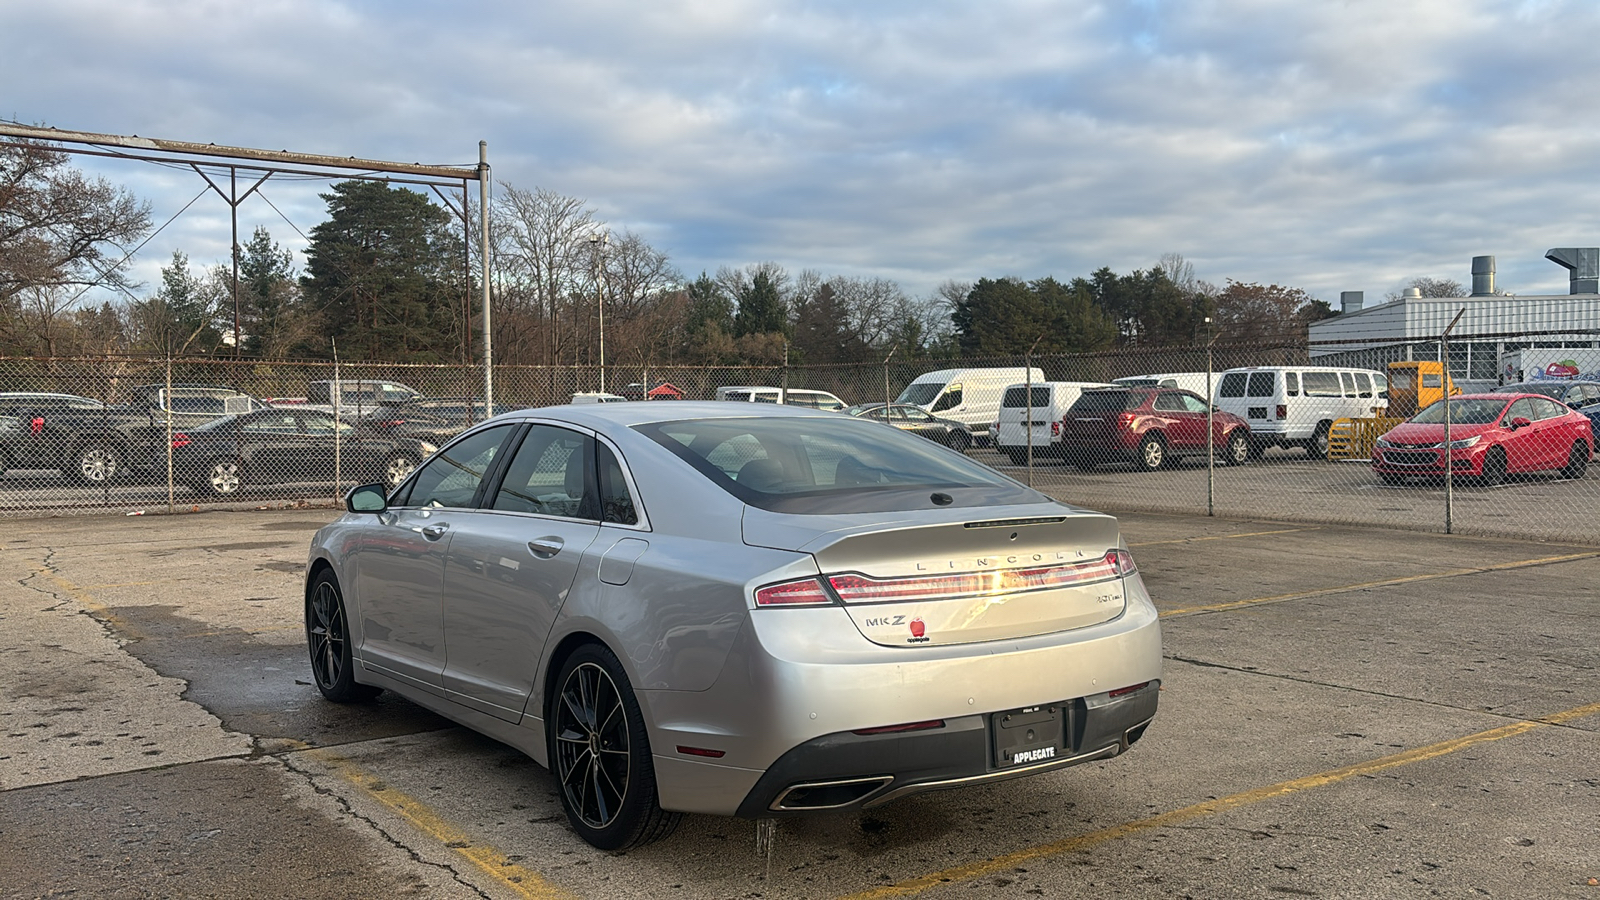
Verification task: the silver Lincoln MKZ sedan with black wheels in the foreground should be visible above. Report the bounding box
[306,402,1162,849]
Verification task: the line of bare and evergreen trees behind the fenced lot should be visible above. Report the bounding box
[0,141,1424,365]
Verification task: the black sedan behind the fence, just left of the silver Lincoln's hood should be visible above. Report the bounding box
[171,410,437,496]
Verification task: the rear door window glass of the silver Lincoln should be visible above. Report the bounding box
[490,424,600,520]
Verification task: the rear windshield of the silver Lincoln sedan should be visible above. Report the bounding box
[634,415,1046,514]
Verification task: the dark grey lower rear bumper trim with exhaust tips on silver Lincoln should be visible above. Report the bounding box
[736,681,1160,818]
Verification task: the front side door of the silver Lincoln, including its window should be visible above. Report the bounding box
[352,423,518,692]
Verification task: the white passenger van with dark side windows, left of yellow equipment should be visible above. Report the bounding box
[1216,365,1389,460]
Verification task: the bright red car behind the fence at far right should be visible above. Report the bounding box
[1373,394,1594,485]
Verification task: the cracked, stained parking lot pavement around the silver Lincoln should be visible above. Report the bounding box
[0,506,1600,898]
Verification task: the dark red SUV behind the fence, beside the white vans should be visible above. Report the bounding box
[1061,388,1250,469]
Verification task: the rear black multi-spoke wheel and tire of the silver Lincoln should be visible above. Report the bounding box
[546,644,683,850]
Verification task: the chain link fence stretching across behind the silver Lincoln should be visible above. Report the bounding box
[0,336,1600,544]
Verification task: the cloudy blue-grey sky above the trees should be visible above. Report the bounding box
[0,0,1600,303]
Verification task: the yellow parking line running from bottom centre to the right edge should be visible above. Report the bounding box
[848,703,1600,900]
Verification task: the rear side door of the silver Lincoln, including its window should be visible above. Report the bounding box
[442,423,600,722]
